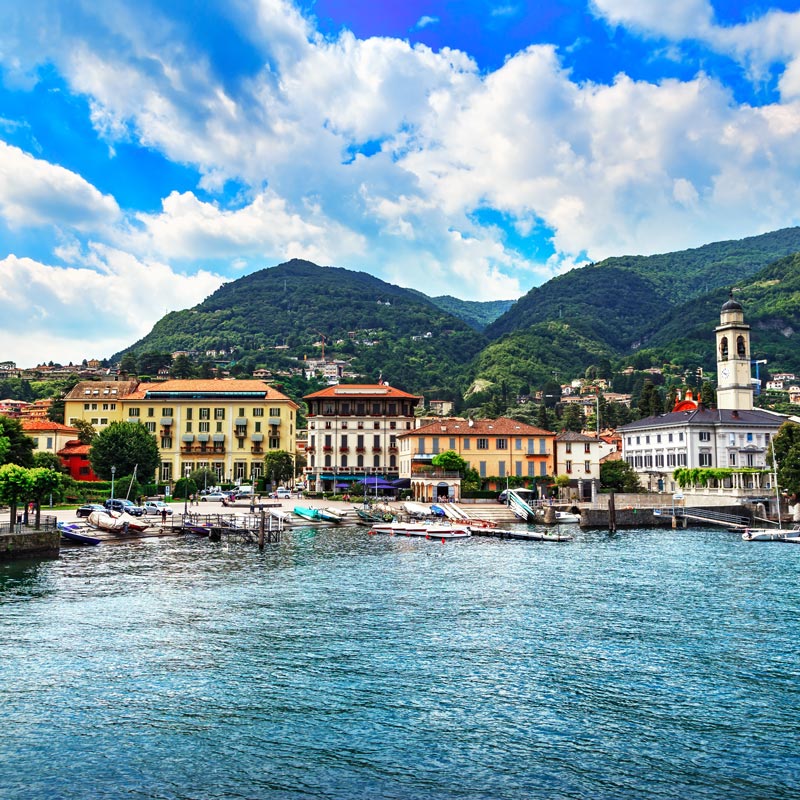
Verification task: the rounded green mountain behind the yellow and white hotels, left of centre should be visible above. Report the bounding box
[115,259,486,399]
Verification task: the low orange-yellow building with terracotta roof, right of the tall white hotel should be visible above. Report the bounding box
[397,417,556,500]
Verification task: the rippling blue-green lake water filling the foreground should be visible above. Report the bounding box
[0,528,800,800]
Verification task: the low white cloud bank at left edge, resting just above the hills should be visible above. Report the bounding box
[0,245,223,365]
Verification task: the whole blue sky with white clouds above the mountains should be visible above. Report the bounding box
[0,0,800,365]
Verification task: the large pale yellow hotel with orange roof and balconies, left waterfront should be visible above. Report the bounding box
[64,380,298,482]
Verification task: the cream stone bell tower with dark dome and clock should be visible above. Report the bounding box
[714,292,753,411]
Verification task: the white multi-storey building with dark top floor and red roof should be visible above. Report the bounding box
[304,384,421,492]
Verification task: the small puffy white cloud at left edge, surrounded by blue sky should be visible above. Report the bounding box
[0,141,120,230]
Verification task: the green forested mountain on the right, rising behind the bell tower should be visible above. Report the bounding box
[470,228,800,388]
